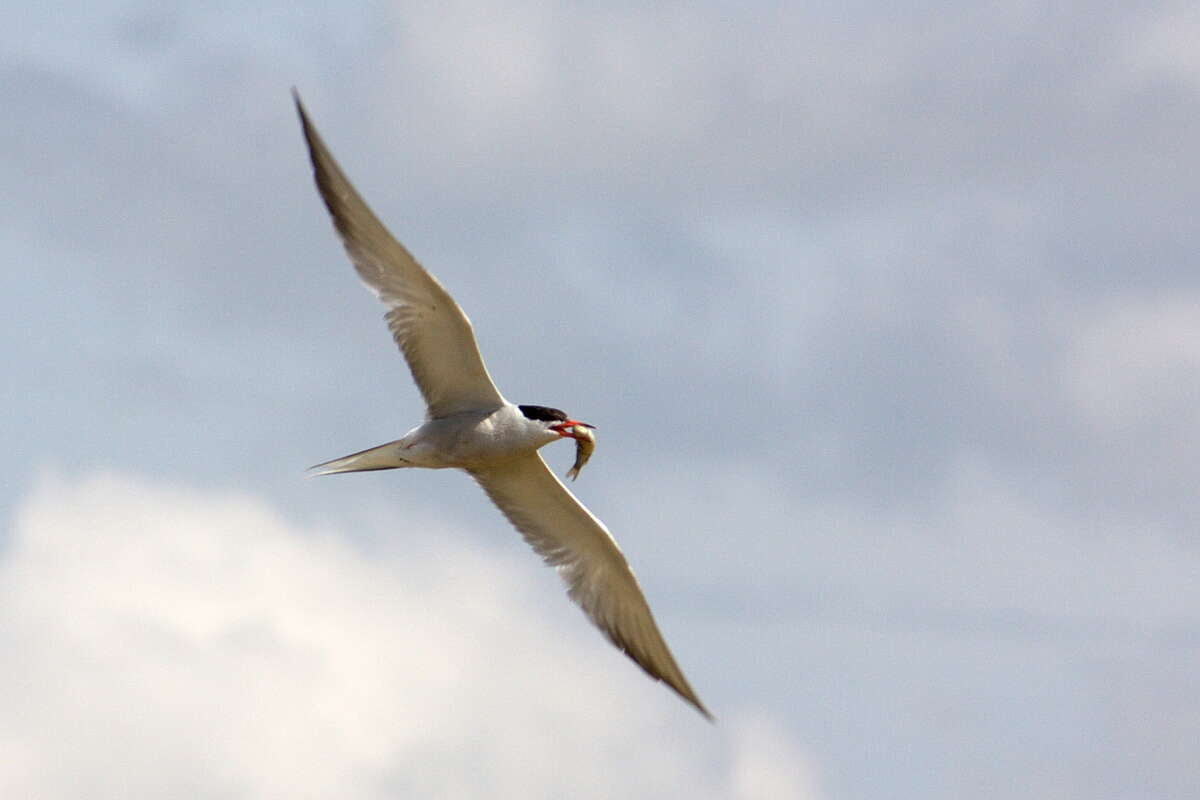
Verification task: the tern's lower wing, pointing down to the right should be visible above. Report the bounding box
[469,453,712,718]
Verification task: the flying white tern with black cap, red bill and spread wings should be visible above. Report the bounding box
[293,92,713,720]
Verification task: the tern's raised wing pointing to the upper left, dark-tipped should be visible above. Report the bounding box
[295,95,504,419]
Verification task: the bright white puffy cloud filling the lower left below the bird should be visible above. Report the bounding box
[0,475,812,799]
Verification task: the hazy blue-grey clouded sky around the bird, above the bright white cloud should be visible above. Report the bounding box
[0,2,1200,796]
